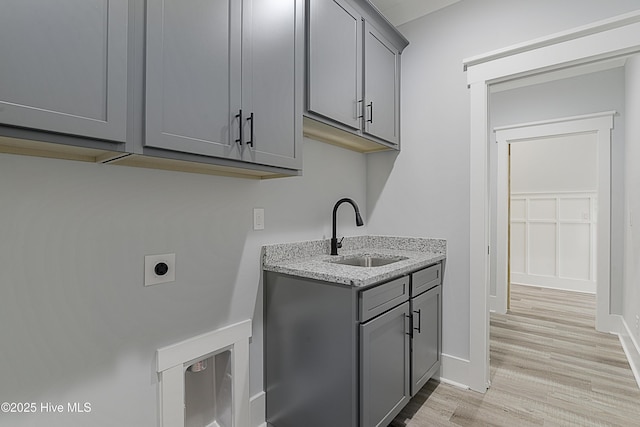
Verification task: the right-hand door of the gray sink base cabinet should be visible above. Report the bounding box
[411,285,442,396]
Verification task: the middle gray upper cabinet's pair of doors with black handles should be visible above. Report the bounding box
[144,0,303,170]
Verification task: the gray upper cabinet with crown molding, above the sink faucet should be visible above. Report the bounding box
[304,0,408,152]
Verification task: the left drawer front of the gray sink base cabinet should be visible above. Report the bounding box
[359,276,409,322]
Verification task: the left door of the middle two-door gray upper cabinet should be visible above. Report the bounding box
[145,0,242,157]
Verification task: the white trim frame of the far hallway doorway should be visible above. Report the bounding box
[493,111,616,316]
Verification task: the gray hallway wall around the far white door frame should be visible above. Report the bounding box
[490,68,627,308]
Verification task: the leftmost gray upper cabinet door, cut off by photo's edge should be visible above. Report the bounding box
[0,0,129,142]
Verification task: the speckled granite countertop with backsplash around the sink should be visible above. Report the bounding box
[262,236,447,287]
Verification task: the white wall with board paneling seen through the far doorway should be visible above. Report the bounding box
[510,134,598,293]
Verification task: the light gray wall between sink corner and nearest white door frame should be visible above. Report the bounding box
[367,0,640,359]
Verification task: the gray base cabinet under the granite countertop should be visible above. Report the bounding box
[264,263,442,427]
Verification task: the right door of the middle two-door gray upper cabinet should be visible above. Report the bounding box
[242,0,304,169]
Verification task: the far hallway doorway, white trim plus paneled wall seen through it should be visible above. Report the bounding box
[490,112,615,316]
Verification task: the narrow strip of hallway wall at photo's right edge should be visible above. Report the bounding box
[623,56,640,368]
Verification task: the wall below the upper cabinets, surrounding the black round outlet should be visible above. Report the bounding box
[0,140,367,427]
